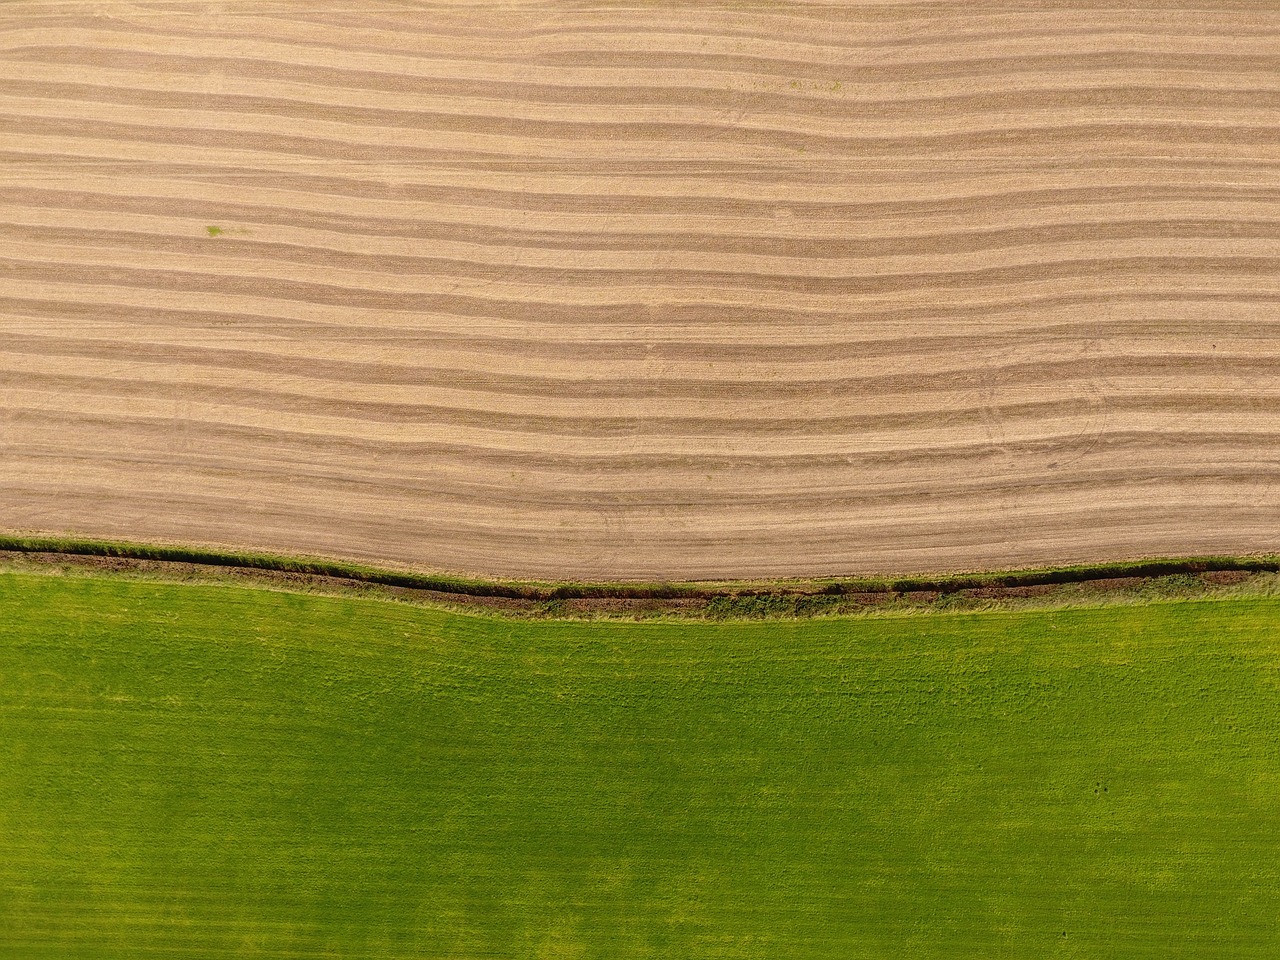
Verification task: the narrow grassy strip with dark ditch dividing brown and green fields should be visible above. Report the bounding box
[0,535,1280,620]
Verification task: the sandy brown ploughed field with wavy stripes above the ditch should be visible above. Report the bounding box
[0,0,1280,577]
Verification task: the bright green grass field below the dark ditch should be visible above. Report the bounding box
[0,573,1280,960]
